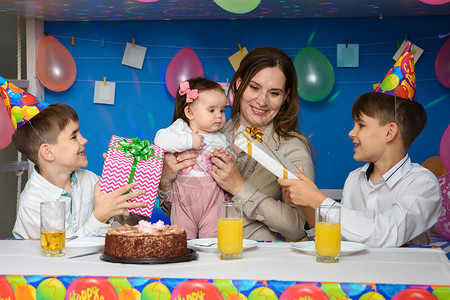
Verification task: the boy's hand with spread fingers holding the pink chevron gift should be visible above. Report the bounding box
[94,180,148,223]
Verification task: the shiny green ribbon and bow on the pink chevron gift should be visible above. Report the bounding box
[109,137,163,194]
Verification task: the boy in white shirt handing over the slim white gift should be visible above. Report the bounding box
[278,44,442,247]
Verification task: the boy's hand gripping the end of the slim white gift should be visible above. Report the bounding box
[278,167,327,209]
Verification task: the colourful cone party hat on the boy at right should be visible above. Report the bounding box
[375,42,416,100]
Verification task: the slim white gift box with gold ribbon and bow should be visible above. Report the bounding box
[234,127,300,179]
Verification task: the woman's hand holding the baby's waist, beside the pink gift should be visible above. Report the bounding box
[159,152,198,191]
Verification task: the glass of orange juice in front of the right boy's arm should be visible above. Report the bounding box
[315,205,341,263]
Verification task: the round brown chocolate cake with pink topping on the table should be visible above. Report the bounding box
[104,220,188,258]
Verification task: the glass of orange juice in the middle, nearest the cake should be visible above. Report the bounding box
[217,202,243,260]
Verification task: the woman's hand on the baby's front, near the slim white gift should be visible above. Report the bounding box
[211,148,244,196]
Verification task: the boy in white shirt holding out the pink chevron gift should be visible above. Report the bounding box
[12,103,146,239]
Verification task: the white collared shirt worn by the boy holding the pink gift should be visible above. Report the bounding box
[13,169,111,239]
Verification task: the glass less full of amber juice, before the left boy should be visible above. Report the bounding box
[41,201,66,256]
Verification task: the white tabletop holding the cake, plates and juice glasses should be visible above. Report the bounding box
[0,240,450,299]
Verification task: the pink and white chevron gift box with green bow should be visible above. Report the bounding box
[100,135,164,217]
